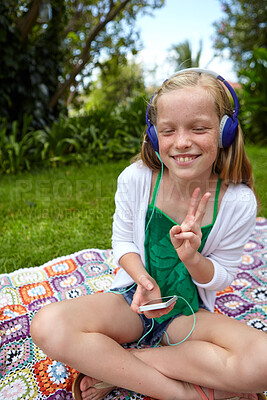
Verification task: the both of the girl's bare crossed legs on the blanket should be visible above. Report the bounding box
[31,293,267,400]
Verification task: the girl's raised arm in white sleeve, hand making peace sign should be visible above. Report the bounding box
[170,185,257,291]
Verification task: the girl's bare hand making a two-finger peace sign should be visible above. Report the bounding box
[170,188,211,265]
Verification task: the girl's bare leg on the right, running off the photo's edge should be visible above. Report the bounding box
[130,310,267,398]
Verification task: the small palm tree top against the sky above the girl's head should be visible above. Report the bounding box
[168,40,202,71]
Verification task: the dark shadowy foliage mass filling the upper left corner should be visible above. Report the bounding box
[0,0,67,134]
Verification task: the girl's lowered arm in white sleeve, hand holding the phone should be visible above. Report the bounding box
[112,164,172,318]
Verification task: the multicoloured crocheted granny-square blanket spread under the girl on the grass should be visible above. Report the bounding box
[0,218,267,400]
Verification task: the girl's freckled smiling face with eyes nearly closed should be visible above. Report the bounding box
[157,86,219,181]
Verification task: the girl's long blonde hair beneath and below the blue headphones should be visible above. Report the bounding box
[139,70,255,191]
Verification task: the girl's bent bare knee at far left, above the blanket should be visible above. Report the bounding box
[30,303,67,360]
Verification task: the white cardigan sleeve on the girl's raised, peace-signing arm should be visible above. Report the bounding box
[195,185,257,291]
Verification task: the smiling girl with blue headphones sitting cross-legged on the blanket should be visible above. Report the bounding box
[31,69,267,400]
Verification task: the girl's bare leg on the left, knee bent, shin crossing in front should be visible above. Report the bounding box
[31,293,198,400]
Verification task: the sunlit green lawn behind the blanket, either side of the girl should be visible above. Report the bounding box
[0,146,267,273]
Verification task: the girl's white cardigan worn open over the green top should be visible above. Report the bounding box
[112,161,257,311]
